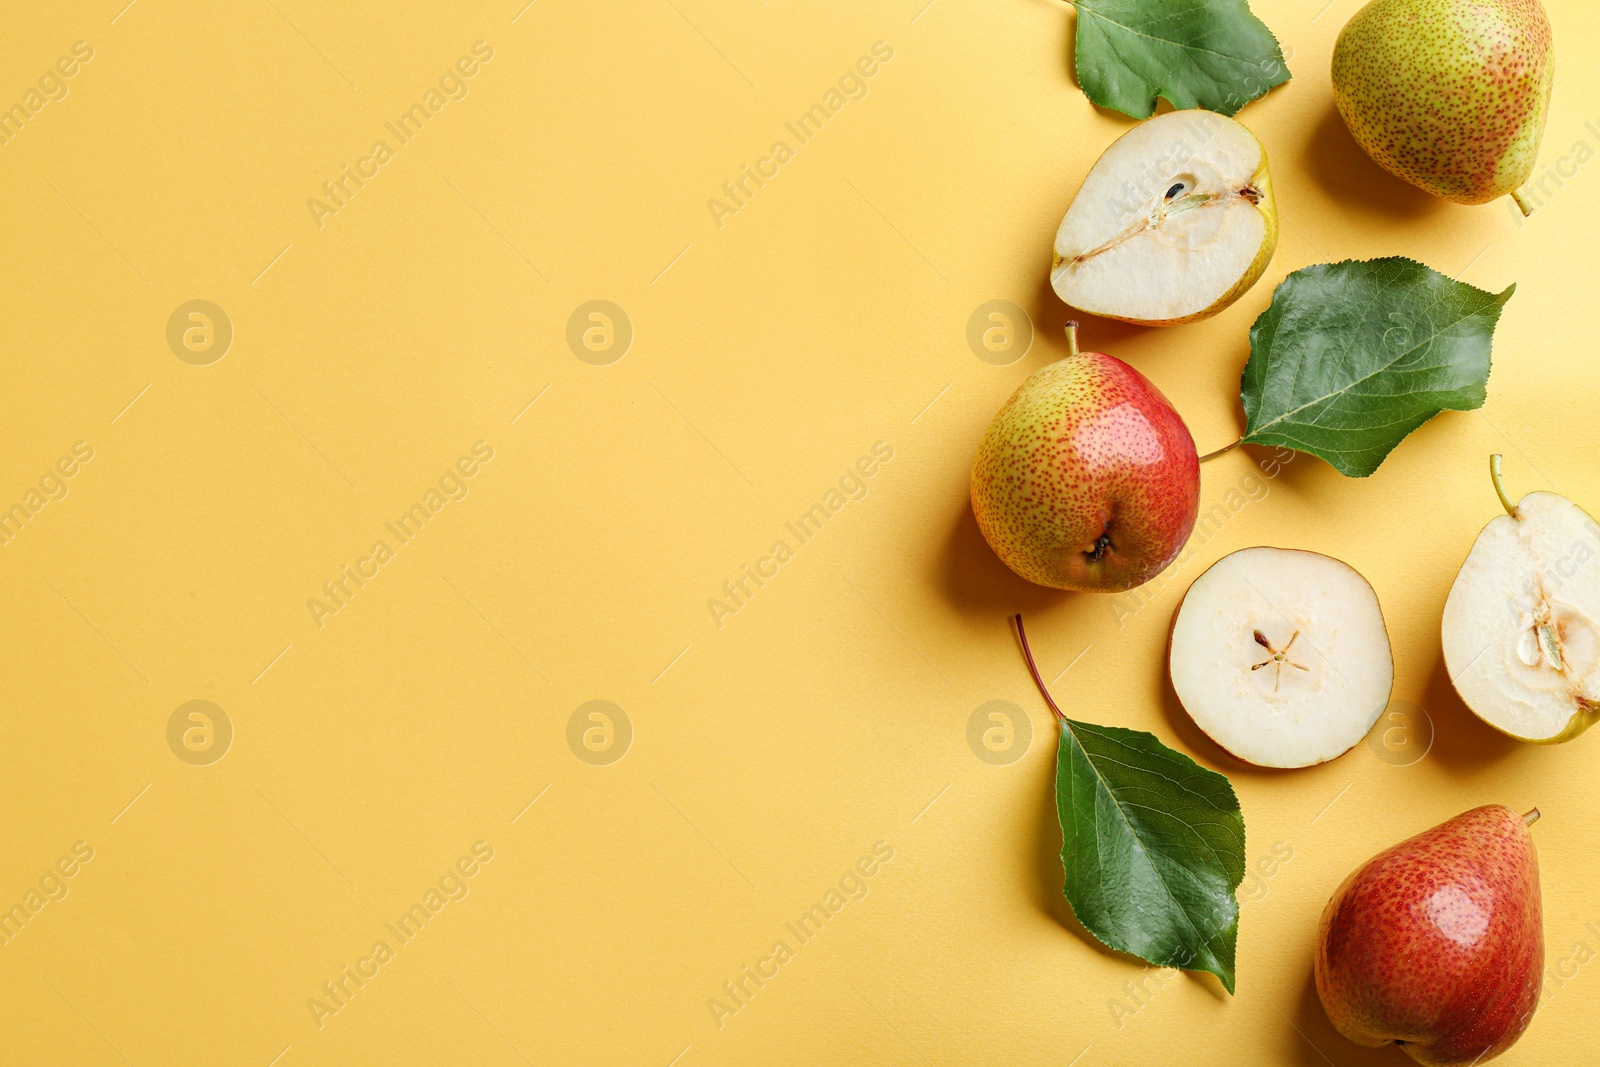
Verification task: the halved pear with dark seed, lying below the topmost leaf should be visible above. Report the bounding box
[1050,110,1278,326]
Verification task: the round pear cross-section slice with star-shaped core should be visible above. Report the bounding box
[1168,547,1395,766]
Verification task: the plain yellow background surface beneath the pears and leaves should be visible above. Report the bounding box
[0,0,1600,1067]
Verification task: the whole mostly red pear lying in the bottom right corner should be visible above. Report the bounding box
[1315,805,1544,1067]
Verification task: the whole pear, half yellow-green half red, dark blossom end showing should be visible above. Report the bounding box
[973,323,1200,592]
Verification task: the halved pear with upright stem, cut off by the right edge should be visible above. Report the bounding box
[1440,456,1600,742]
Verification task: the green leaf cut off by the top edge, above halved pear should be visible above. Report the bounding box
[1072,0,1290,118]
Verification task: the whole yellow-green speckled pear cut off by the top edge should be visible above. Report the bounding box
[1333,0,1555,214]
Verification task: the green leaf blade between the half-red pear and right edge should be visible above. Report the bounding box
[1240,256,1517,478]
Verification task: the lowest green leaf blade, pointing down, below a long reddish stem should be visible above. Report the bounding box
[1056,718,1245,992]
